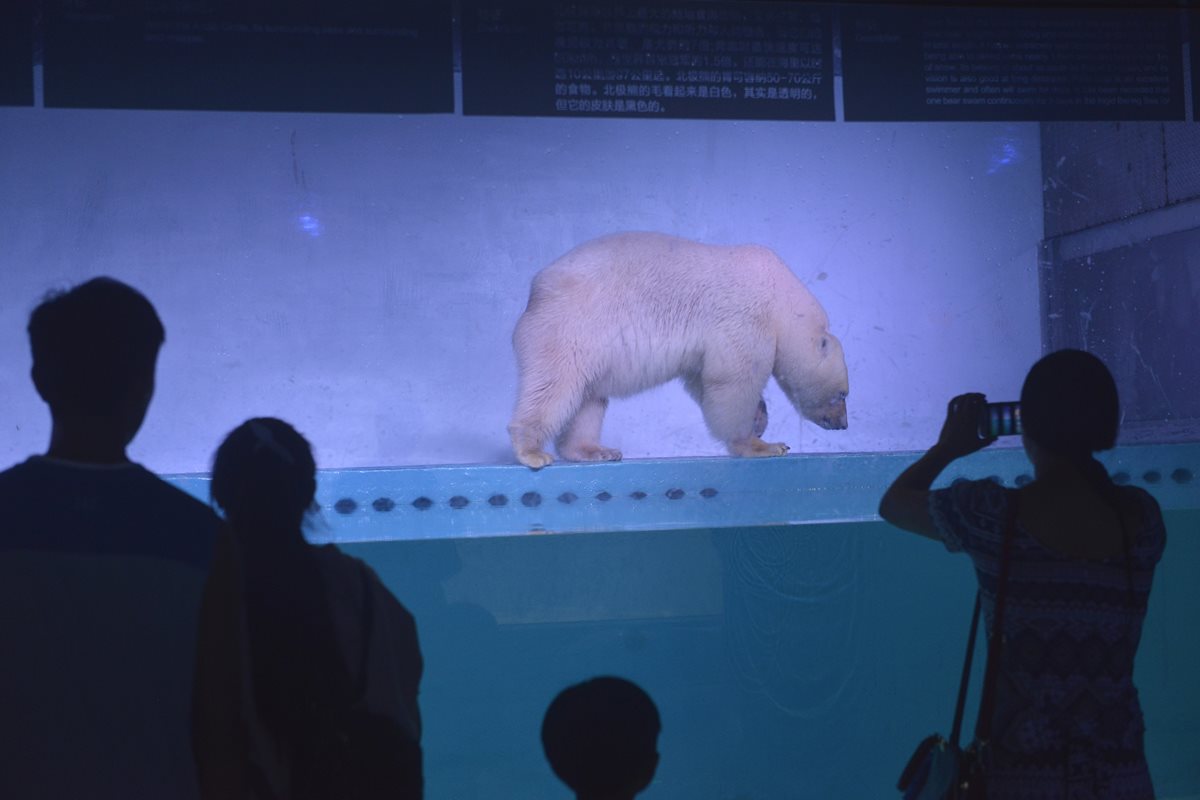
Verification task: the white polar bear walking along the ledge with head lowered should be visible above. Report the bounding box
[509,233,850,469]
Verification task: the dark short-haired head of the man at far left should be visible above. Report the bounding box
[28,278,166,444]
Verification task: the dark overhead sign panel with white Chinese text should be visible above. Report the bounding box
[462,0,834,120]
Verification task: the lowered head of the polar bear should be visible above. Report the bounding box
[775,331,850,431]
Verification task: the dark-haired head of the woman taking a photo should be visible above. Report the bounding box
[1021,350,1121,461]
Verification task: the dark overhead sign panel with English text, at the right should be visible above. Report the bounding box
[841,6,1184,121]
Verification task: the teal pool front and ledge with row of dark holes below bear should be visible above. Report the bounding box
[169,445,1200,800]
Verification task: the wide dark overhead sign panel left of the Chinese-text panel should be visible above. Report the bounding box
[44,0,454,114]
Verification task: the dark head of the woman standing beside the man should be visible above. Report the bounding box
[210,416,317,533]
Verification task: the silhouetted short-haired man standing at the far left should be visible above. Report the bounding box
[0,278,218,799]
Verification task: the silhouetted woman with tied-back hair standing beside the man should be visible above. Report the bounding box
[193,417,422,799]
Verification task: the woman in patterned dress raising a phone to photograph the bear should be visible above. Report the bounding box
[880,350,1165,800]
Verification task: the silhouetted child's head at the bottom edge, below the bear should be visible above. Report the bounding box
[541,678,662,800]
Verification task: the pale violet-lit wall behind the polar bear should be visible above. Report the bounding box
[0,109,1042,473]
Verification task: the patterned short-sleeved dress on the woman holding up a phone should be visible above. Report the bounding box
[929,480,1166,800]
